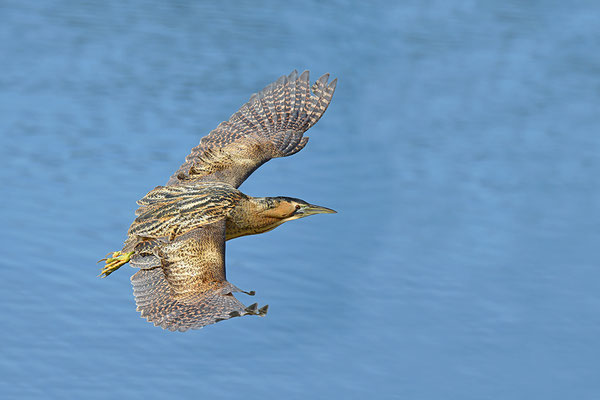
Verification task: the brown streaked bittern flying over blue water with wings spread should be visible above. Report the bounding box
[101,71,337,331]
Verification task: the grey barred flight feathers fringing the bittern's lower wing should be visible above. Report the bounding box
[131,267,268,332]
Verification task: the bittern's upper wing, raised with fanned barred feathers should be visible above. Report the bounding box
[167,71,337,188]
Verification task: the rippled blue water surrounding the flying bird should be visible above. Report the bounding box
[0,0,600,400]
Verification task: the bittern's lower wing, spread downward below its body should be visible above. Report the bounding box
[130,219,267,331]
